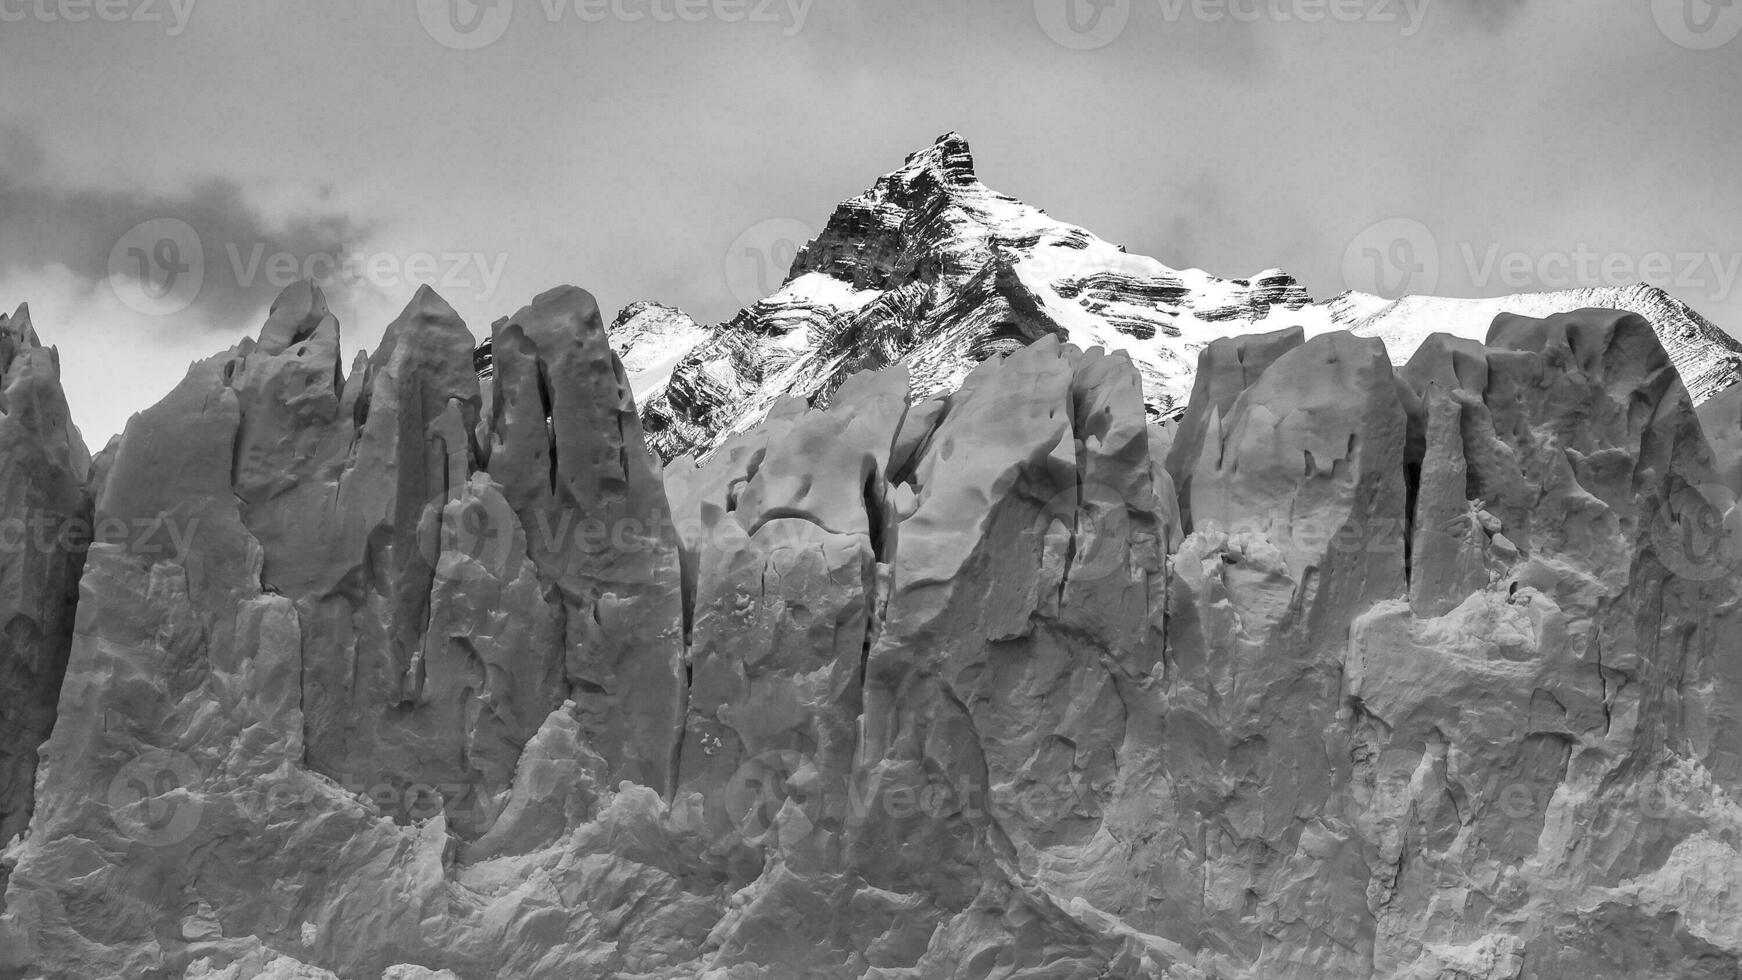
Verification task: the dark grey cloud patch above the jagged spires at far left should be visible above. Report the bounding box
[0,125,371,331]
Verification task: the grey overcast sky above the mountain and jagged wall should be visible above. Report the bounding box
[0,0,1742,447]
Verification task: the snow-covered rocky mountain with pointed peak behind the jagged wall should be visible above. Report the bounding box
[479,132,1742,460]
